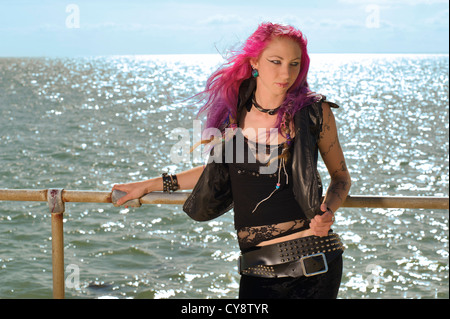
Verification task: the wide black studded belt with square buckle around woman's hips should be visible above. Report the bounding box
[238,233,344,278]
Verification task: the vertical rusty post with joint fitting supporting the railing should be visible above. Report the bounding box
[47,189,65,299]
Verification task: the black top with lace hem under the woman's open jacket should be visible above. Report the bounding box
[228,130,309,250]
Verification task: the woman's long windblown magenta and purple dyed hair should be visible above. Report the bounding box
[199,23,320,135]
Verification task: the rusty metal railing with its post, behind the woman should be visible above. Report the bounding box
[0,189,449,299]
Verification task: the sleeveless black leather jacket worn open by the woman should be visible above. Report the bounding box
[183,81,339,221]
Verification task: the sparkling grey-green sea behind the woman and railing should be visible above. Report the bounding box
[0,54,449,299]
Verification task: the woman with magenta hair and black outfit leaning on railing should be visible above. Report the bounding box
[113,23,351,298]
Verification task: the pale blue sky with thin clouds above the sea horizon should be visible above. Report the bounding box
[0,0,449,57]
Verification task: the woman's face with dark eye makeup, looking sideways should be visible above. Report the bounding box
[250,37,302,96]
